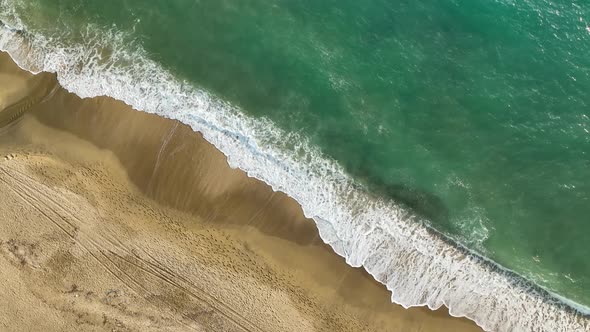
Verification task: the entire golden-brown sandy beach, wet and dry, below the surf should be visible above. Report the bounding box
[0,50,479,332]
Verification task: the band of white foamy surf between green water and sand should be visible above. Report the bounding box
[0,6,590,331]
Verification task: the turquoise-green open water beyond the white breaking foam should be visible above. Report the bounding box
[0,0,590,328]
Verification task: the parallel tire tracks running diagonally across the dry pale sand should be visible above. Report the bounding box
[0,163,263,332]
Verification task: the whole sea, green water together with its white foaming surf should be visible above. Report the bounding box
[0,0,590,331]
